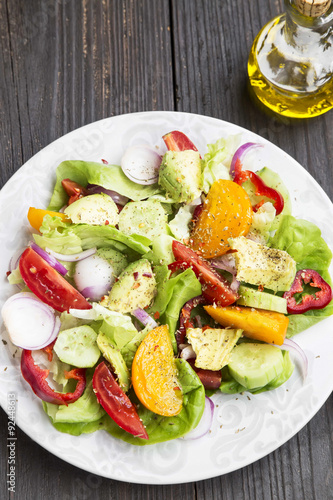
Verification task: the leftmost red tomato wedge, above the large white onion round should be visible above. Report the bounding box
[19,247,92,312]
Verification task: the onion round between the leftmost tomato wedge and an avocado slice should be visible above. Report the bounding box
[74,255,115,301]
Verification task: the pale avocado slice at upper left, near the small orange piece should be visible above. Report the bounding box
[64,193,119,226]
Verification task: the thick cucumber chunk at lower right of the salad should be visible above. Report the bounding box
[228,342,283,389]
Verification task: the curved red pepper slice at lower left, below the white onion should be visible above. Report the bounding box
[21,349,86,406]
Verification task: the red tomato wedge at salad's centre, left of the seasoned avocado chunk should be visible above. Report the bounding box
[172,240,239,306]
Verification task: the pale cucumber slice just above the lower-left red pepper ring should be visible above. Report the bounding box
[53,325,101,368]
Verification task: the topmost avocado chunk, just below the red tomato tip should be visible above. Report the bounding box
[158,150,202,205]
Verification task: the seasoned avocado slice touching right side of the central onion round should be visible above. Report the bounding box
[101,259,157,314]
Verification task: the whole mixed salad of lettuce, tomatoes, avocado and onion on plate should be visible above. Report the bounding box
[2,131,333,445]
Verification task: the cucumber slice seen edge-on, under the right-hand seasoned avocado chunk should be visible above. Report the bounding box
[237,285,287,314]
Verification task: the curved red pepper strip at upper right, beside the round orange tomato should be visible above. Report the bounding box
[234,158,284,215]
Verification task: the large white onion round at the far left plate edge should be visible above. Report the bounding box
[1,292,60,350]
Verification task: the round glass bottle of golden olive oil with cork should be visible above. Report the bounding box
[248,0,333,118]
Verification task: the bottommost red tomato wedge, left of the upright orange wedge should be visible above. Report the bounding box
[93,361,149,439]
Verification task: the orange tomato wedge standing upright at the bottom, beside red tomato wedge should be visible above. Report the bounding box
[132,325,183,417]
